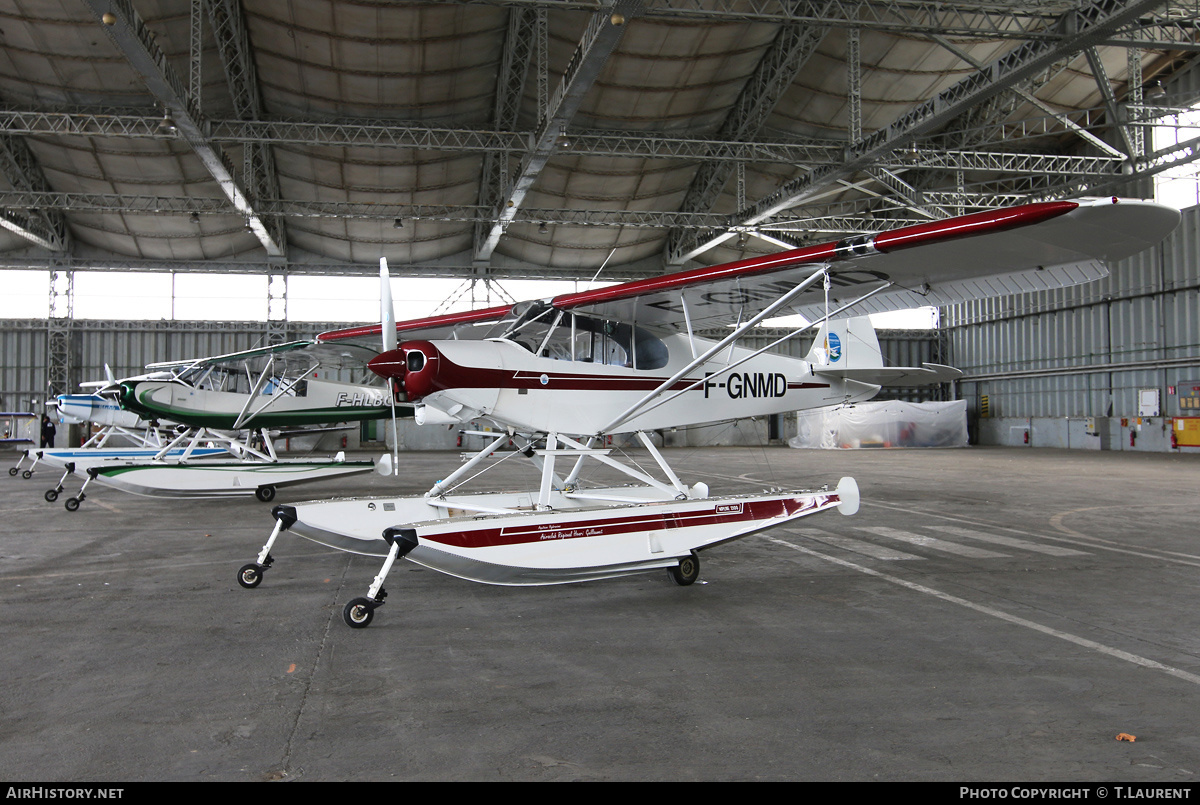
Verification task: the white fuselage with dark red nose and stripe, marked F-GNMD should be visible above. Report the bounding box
[371,335,878,434]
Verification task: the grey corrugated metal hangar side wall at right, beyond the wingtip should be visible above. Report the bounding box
[942,208,1200,417]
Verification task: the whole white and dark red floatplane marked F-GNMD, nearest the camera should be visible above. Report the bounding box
[238,198,1180,627]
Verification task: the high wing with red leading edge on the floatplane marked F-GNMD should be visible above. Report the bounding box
[317,197,1180,342]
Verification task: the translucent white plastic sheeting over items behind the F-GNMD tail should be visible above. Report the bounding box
[788,400,967,450]
